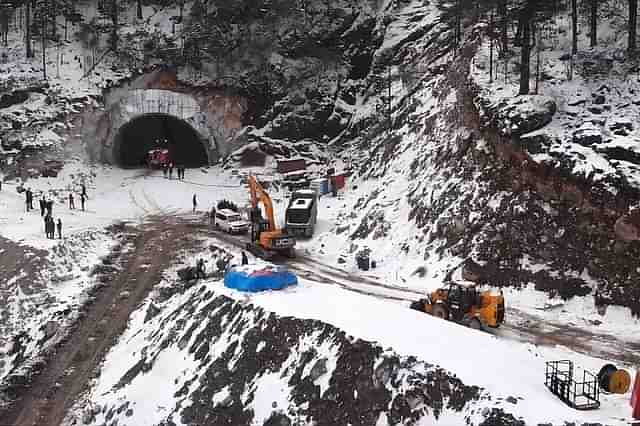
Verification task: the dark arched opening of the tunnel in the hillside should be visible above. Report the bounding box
[113,113,209,168]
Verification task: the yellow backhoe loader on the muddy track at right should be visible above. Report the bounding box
[411,282,504,330]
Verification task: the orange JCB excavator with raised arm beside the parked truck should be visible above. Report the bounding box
[247,176,296,260]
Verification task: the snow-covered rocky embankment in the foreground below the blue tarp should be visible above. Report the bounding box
[62,245,626,425]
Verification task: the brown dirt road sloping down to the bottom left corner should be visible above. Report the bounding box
[0,217,204,426]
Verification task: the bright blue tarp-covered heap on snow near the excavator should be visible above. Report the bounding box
[224,265,298,292]
